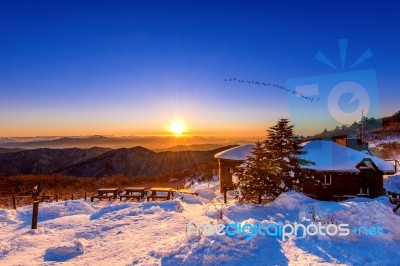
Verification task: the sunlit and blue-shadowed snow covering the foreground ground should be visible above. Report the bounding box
[0,177,400,265]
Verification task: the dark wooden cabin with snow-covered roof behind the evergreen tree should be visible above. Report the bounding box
[215,140,396,200]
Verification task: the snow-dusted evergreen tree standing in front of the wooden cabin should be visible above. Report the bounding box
[236,119,314,200]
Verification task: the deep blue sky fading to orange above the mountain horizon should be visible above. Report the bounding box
[0,0,400,138]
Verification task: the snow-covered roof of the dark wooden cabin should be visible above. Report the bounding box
[215,140,395,174]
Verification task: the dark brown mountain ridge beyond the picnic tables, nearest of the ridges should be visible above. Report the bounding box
[0,146,238,177]
